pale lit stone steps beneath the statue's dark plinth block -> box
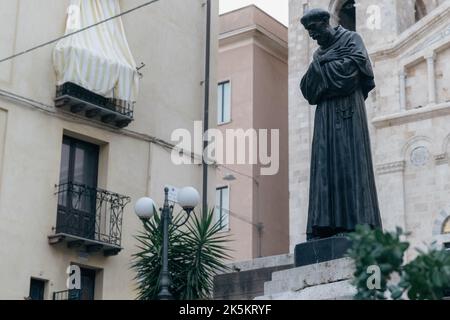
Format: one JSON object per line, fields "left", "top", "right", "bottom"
{"left": 255, "top": 258, "right": 356, "bottom": 300}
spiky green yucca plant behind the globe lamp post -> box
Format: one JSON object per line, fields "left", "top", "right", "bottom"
{"left": 133, "top": 210, "right": 230, "bottom": 300}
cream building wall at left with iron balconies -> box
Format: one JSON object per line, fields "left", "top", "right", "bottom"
{"left": 0, "top": 0, "right": 218, "bottom": 299}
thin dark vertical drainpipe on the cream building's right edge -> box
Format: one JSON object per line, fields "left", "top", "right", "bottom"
{"left": 202, "top": 0, "right": 211, "bottom": 216}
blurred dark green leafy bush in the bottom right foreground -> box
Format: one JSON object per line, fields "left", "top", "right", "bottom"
{"left": 349, "top": 226, "right": 450, "bottom": 300}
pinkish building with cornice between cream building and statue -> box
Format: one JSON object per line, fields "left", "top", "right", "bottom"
{"left": 216, "top": 5, "right": 289, "bottom": 261}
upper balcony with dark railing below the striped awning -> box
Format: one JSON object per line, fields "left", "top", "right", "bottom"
{"left": 55, "top": 82, "right": 134, "bottom": 128}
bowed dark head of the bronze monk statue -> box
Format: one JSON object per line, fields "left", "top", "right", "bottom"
{"left": 300, "top": 9, "right": 333, "bottom": 46}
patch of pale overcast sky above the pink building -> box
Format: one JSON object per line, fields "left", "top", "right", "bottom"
{"left": 219, "top": 0, "right": 289, "bottom": 26}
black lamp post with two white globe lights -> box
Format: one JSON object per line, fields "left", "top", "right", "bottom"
{"left": 134, "top": 187, "right": 200, "bottom": 300}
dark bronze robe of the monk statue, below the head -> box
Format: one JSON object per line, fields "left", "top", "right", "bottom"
{"left": 301, "top": 26, "right": 381, "bottom": 239}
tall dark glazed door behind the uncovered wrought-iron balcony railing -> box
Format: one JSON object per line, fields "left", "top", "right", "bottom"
{"left": 56, "top": 136, "right": 99, "bottom": 239}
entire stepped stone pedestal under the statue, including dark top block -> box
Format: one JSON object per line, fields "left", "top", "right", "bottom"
{"left": 214, "top": 237, "right": 356, "bottom": 300}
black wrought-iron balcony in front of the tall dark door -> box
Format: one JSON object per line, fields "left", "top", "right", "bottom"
{"left": 48, "top": 183, "right": 131, "bottom": 256}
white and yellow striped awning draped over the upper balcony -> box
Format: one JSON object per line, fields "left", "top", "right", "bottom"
{"left": 53, "top": 0, "right": 139, "bottom": 102}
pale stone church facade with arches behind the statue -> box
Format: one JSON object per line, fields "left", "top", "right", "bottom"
{"left": 289, "top": 0, "right": 450, "bottom": 258}
